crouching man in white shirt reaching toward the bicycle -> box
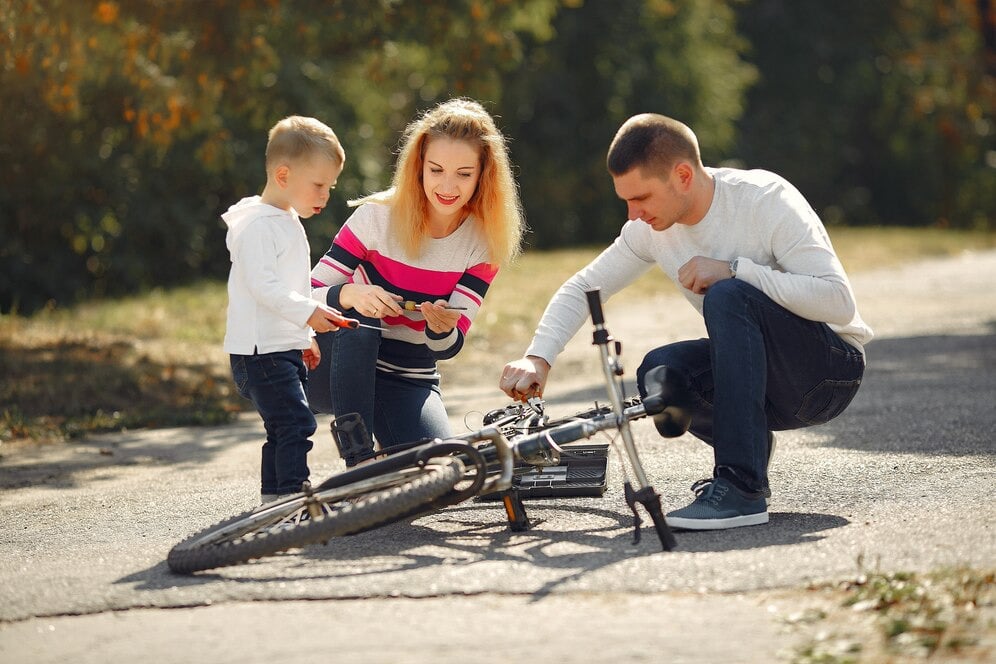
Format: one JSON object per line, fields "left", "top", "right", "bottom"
{"left": 499, "top": 113, "right": 872, "bottom": 530}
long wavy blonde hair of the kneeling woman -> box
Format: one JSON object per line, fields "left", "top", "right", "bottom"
{"left": 349, "top": 99, "right": 524, "bottom": 265}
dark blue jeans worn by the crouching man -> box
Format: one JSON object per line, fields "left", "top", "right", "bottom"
{"left": 637, "top": 279, "right": 865, "bottom": 493}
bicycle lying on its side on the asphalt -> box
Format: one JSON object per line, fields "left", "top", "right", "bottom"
{"left": 167, "top": 289, "right": 690, "bottom": 574}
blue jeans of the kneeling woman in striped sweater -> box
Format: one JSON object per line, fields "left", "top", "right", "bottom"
{"left": 308, "top": 311, "right": 452, "bottom": 448}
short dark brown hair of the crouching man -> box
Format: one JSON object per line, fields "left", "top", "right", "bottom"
{"left": 605, "top": 113, "right": 702, "bottom": 176}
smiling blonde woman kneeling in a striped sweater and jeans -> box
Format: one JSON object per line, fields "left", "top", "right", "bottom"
{"left": 308, "top": 99, "right": 523, "bottom": 467}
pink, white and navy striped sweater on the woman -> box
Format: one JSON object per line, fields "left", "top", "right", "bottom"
{"left": 311, "top": 203, "right": 497, "bottom": 382}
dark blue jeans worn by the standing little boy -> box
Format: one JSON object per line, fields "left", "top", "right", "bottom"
{"left": 230, "top": 350, "right": 317, "bottom": 494}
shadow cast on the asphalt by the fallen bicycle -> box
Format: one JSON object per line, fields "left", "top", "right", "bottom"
{"left": 117, "top": 501, "right": 850, "bottom": 600}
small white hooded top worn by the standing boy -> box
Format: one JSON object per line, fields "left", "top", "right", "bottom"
{"left": 221, "top": 196, "right": 319, "bottom": 355}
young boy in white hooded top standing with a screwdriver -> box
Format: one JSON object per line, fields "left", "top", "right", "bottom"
{"left": 222, "top": 116, "right": 346, "bottom": 503}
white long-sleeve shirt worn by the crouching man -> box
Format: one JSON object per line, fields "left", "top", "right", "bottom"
{"left": 526, "top": 168, "right": 873, "bottom": 365}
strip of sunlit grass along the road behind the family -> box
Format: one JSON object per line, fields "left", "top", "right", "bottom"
{"left": 0, "top": 228, "right": 996, "bottom": 442}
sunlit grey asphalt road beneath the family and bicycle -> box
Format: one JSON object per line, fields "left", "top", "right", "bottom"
{"left": 0, "top": 252, "right": 996, "bottom": 664}
